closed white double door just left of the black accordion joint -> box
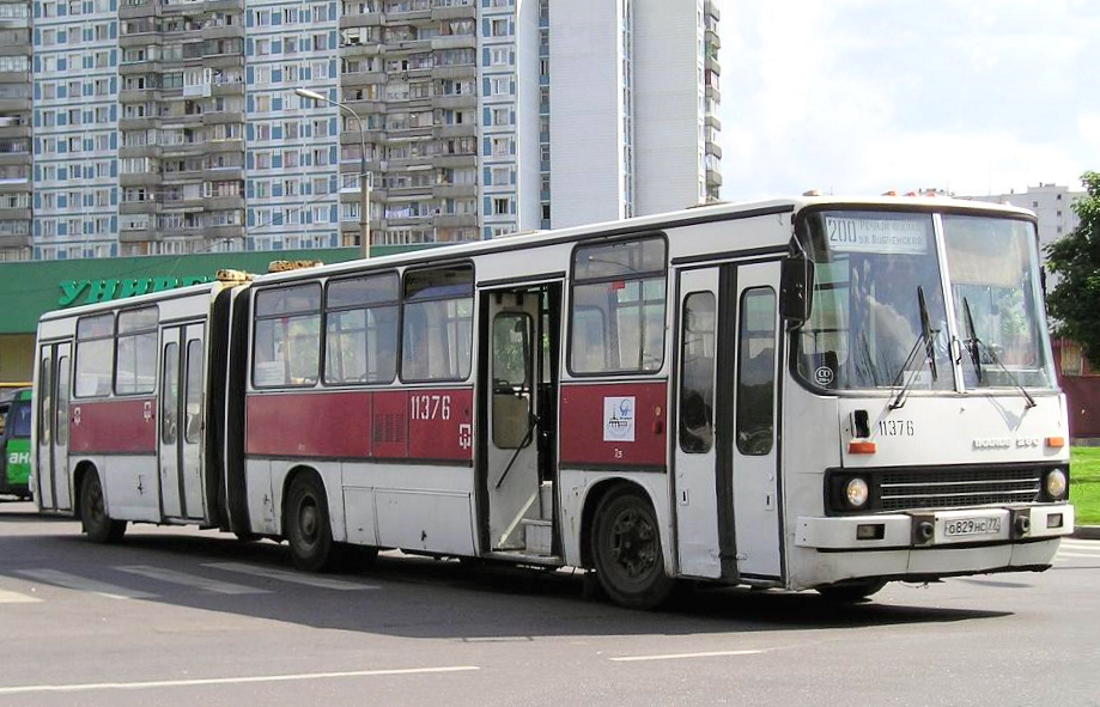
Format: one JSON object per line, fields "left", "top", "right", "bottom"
{"left": 158, "top": 324, "right": 206, "bottom": 520}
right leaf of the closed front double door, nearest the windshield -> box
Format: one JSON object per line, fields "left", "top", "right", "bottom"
{"left": 724, "top": 262, "right": 782, "bottom": 579}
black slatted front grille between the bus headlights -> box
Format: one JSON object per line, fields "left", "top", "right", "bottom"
{"left": 879, "top": 468, "right": 1042, "bottom": 511}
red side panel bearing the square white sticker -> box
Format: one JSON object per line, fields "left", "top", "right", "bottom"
{"left": 561, "top": 382, "right": 669, "bottom": 466}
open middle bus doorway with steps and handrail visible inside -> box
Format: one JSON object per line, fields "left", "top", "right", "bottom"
{"left": 477, "top": 283, "right": 561, "bottom": 555}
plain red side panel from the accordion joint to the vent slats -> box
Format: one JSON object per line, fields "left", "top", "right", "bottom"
{"left": 245, "top": 393, "right": 371, "bottom": 457}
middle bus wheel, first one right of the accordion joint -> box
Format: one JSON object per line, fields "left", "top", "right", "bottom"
{"left": 286, "top": 473, "right": 339, "bottom": 572}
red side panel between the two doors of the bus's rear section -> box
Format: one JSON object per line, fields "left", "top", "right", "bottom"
{"left": 69, "top": 398, "right": 156, "bottom": 454}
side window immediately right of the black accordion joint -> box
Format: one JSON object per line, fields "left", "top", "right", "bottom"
{"left": 252, "top": 283, "right": 321, "bottom": 388}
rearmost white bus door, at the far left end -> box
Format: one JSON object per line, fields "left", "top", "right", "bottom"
{"left": 34, "top": 342, "right": 73, "bottom": 510}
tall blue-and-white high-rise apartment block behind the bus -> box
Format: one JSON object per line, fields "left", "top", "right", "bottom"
{"left": 12, "top": 0, "right": 721, "bottom": 259}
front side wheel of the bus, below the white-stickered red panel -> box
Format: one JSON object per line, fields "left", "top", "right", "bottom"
{"left": 592, "top": 488, "right": 673, "bottom": 609}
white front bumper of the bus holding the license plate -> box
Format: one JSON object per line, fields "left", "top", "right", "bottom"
{"left": 794, "top": 504, "right": 1074, "bottom": 551}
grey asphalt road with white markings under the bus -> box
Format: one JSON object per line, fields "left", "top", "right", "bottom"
{"left": 0, "top": 502, "right": 1100, "bottom": 707}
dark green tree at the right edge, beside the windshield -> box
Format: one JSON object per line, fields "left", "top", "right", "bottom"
{"left": 1046, "top": 172, "right": 1100, "bottom": 368}
